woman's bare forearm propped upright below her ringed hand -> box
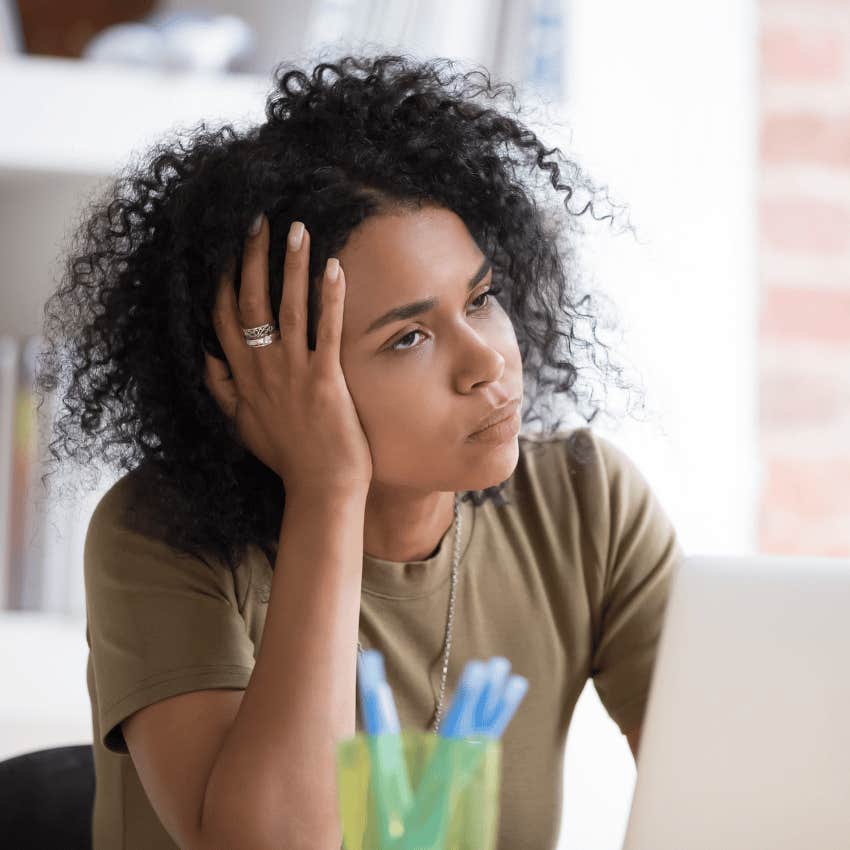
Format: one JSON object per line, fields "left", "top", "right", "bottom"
{"left": 201, "top": 489, "right": 366, "bottom": 850}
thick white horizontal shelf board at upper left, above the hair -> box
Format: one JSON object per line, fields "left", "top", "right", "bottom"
{"left": 0, "top": 55, "right": 274, "bottom": 182}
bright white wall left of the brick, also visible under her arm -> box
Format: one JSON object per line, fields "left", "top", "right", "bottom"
{"left": 558, "top": 0, "right": 760, "bottom": 850}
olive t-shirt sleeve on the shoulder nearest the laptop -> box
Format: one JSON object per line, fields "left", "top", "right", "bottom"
{"left": 591, "top": 435, "right": 684, "bottom": 734}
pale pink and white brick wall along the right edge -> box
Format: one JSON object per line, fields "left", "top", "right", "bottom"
{"left": 759, "top": 0, "right": 850, "bottom": 557}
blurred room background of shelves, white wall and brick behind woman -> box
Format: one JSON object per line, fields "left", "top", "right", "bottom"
{"left": 0, "top": 0, "right": 850, "bottom": 850}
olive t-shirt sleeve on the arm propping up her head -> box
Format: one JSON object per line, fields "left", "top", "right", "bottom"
{"left": 84, "top": 480, "right": 254, "bottom": 753}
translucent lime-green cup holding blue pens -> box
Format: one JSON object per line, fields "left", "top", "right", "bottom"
{"left": 336, "top": 729, "right": 502, "bottom": 850}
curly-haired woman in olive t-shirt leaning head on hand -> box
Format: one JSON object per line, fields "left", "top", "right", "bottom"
{"left": 39, "top": 49, "right": 681, "bottom": 850}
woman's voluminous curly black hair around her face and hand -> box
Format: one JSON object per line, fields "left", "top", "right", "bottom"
{"left": 35, "top": 53, "right": 644, "bottom": 569}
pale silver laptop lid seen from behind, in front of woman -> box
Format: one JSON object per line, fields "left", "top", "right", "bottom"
{"left": 623, "top": 555, "right": 850, "bottom": 850}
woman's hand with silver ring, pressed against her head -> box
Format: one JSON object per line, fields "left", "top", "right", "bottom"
{"left": 204, "top": 215, "right": 372, "bottom": 490}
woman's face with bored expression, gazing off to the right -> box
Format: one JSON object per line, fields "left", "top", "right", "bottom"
{"left": 338, "top": 207, "right": 522, "bottom": 492}
